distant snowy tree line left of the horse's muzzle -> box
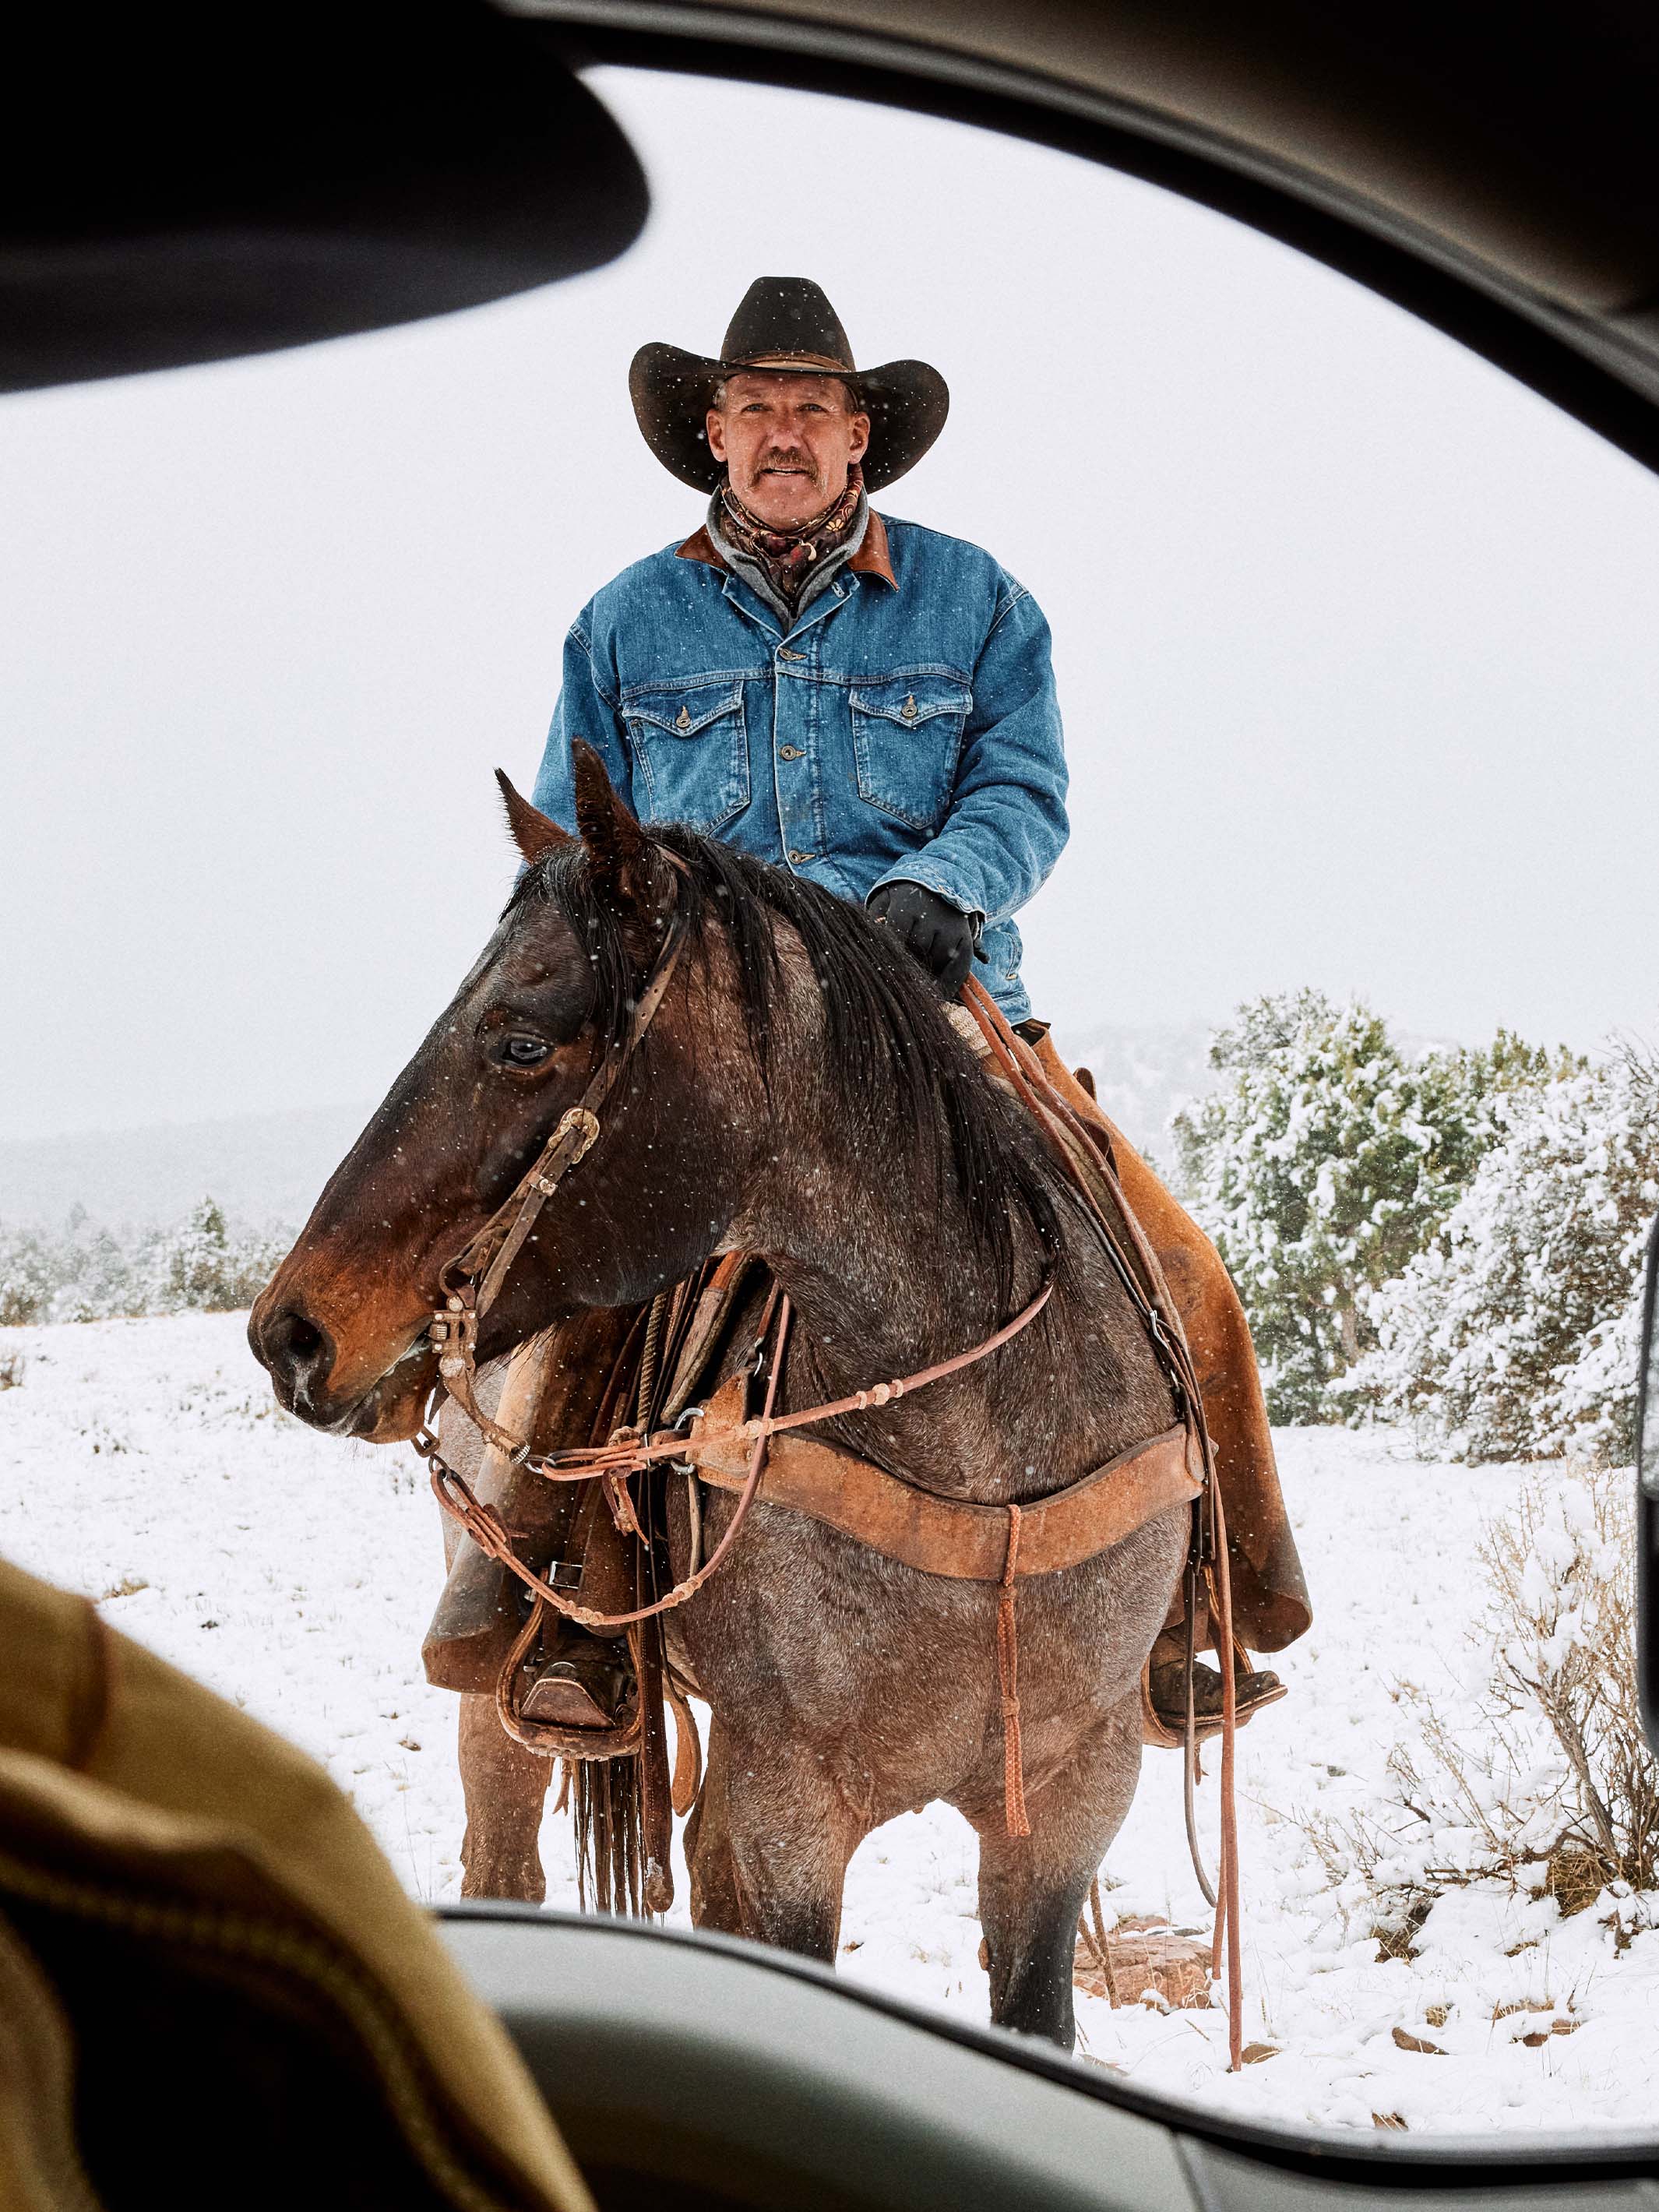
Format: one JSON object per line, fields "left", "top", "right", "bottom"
{"left": 0, "top": 1199, "right": 292, "bottom": 1327}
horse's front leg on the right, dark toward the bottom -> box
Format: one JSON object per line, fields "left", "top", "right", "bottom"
{"left": 971, "top": 1685, "right": 1141, "bottom": 2051}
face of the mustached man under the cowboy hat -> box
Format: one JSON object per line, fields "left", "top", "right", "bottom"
{"left": 708, "top": 369, "right": 869, "bottom": 531}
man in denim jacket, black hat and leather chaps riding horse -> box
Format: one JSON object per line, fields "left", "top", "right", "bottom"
{"left": 424, "top": 276, "right": 1312, "bottom": 1743}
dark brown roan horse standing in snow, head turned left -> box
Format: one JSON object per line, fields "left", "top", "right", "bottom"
{"left": 250, "top": 745, "right": 1190, "bottom": 2046}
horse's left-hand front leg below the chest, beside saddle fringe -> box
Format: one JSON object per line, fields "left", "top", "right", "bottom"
{"left": 692, "top": 1725, "right": 858, "bottom": 1967}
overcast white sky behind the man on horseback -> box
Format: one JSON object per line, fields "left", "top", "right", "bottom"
{"left": 0, "top": 71, "right": 1659, "bottom": 1137}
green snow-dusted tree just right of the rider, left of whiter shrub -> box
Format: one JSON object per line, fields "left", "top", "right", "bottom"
{"left": 1172, "top": 991, "right": 1551, "bottom": 1420}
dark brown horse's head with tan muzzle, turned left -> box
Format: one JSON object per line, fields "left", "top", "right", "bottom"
{"left": 248, "top": 745, "right": 766, "bottom": 1442}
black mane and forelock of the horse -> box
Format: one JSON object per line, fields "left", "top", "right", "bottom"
{"left": 506, "top": 822, "right": 1071, "bottom": 1309}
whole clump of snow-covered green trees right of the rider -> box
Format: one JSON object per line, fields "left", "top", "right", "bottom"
{"left": 1172, "top": 991, "right": 1659, "bottom": 1462}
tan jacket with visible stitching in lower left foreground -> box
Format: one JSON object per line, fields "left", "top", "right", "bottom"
{"left": 0, "top": 1562, "right": 590, "bottom": 2212}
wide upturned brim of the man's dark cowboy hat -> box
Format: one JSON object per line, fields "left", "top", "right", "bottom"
{"left": 629, "top": 345, "right": 951, "bottom": 491}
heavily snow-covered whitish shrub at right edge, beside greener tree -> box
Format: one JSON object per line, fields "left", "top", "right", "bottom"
{"left": 1349, "top": 1053, "right": 1659, "bottom": 1460}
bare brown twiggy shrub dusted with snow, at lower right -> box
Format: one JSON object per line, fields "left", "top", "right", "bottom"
{"left": 1303, "top": 1469, "right": 1659, "bottom": 1951}
